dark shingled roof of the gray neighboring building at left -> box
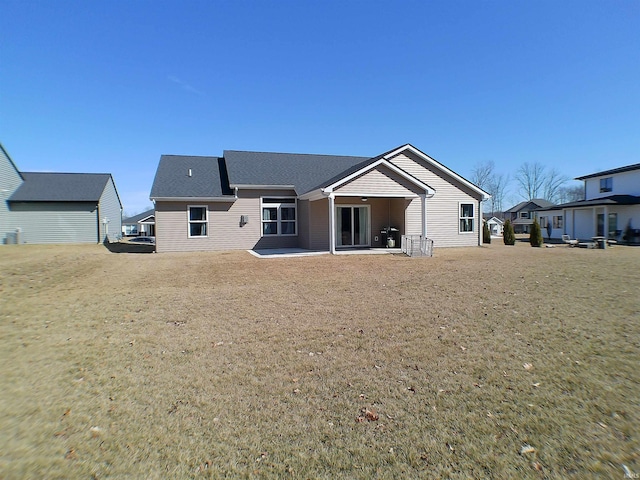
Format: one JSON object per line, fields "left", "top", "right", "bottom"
{"left": 9, "top": 172, "right": 111, "bottom": 202}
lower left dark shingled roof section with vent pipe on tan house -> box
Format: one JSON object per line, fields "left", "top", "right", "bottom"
{"left": 150, "top": 155, "right": 233, "bottom": 198}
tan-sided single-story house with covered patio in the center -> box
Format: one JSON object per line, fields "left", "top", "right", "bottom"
{"left": 150, "top": 144, "right": 488, "bottom": 253}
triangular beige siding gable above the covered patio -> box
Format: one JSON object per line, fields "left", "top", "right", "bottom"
{"left": 335, "top": 166, "right": 424, "bottom": 197}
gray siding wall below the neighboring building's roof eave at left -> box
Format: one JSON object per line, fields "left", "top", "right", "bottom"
{"left": 11, "top": 202, "right": 98, "bottom": 243}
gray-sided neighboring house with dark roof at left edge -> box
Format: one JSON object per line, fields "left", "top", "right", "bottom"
{"left": 0, "top": 145, "right": 122, "bottom": 244}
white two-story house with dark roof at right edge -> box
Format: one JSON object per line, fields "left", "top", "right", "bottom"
{"left": 536, "top": 163, "right": 640, "bottom": 242}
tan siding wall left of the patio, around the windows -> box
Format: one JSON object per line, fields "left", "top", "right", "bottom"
{"left": 155, "top": 190, "right": 300, "bottom": 252}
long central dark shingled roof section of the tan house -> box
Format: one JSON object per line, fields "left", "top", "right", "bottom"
{"left": 224, "top": 150, "right": 371, "bottom": 195}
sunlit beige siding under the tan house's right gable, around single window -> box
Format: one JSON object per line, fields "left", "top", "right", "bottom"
{"left": 390, "top": 154, "right": 482, "bottom": 247}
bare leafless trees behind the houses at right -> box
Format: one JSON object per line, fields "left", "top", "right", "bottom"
{"left": 471, "top": 160, "right": 584, "bottom": 213}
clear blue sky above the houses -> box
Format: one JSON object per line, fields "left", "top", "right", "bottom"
{"left": 0, "top": 0, "right": 640, "bottom": 214}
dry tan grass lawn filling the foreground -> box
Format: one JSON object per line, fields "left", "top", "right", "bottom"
{"left": 0, "top": 244, "right": 640, "bottom": 479}
